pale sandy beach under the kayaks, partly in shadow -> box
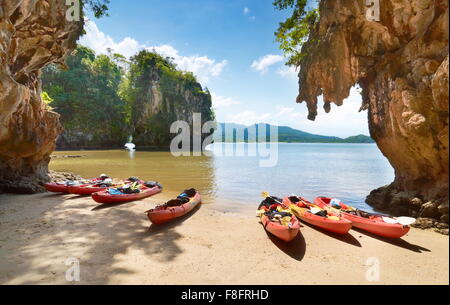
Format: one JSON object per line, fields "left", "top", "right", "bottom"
{"left": 0, "top": 193, "right": 449, "bottom": 284}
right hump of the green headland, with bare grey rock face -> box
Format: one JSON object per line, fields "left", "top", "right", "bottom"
{"left": 130, "top": 51, "right": 214, "bottom": 147}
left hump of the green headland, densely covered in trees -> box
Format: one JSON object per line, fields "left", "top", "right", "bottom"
{"left": 42, "top": 46, "right": 126, "bottom": 146}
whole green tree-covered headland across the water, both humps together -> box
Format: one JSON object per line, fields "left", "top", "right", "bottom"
{"left": 42, "top": 46, "right": 213, "bottom": 148}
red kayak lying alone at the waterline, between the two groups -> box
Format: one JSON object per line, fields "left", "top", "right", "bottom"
{"left": 147, "top": 190, "right": 202, "bottom": 225}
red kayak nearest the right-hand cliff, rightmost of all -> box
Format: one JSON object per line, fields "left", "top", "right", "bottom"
{"left": 314, "top": 197, "right": 410, "bottom": 238}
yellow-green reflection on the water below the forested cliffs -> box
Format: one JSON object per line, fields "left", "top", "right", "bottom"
{"left": 50, "top": 150, "right": 215, "bottom": 199}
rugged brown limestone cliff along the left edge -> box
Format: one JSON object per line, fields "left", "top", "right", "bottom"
{"left": 0, "top": 0, "right": 82, "bottom": 192}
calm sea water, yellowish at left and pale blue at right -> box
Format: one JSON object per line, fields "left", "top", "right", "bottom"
{"left": 50, "top": 144, "right": 394, "bottom": 211}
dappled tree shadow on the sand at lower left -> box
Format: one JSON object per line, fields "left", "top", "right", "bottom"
{"left": 0, "top": 194, "right": 188, "bottom": 284}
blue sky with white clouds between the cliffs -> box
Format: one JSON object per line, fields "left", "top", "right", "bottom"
{"left": 81, "top": 0, "right": 368, "bottom": 137}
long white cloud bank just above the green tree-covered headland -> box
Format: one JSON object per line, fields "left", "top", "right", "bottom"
{"left": 80, "top": 20, "right": 228, "bottom": 83}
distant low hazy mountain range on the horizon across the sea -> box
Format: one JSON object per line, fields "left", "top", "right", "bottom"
{"left": 214, "top": 123, "right": 375, "bottom": 143}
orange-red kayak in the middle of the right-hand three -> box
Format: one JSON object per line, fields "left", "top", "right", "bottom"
{"left": 283, "top": 197, "right": 352, "bottom": 235}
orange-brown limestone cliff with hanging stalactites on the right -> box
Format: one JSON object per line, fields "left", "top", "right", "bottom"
{"left": 297, "top": 0, "right": 449, "bottom": 228}
